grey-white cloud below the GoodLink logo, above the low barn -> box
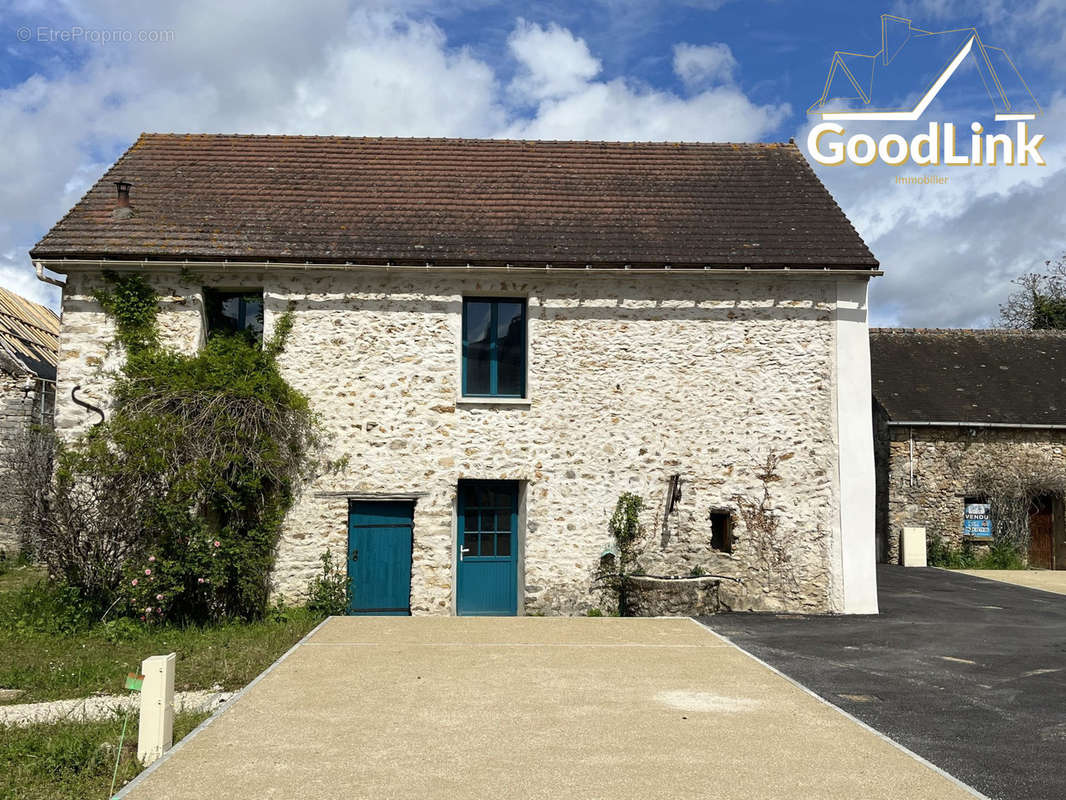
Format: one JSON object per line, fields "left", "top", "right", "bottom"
{"left": 796, "top": 95, "right": 1066, "bottom": 327}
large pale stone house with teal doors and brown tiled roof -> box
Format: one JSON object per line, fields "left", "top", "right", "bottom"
{"left": 31, "top": 134, "right": 879, "bottom": 614}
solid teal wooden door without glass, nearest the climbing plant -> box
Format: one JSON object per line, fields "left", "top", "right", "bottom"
{"left": 348, "top": 500, "right": 415, "bottom": 615}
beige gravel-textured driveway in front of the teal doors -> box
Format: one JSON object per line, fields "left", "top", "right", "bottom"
{"left": 120, "top": 618, "right": 973, "bottom": 800}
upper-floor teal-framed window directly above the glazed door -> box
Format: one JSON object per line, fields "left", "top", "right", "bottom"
{"left": 463, "top": 298, "right": 526, "bottom": 398}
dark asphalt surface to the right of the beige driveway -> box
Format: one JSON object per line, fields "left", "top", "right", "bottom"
{"left": 706, "top": 565, "right": 1066, "bottom": 800}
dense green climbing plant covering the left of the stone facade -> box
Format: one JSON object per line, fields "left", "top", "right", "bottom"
{"left": 56, "top": 273, "right": 319, "bottom": 622}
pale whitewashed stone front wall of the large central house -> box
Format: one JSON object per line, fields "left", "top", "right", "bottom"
{"left": 58, "top": 270, "right": 840, "bottom": 614}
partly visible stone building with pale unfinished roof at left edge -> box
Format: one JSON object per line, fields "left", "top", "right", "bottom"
{"left": 0, "top": 288, "right": 60, "bottom": 555}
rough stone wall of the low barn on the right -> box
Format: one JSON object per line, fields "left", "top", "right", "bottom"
{"left": 877, "top": 425, "right": 1066, "bottom": 564}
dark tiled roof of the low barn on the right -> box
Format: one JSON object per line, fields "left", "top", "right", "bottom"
{"left": 870, "top": 327, "right": 1066, "bottom": 425}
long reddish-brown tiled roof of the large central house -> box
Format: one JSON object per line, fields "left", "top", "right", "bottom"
{"left": 31, "top": 133, "right": 877, "bottom": 269}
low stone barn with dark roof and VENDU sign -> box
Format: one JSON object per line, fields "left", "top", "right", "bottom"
{"left": 870, "top": 329, "right": 1066, "bottom": 569}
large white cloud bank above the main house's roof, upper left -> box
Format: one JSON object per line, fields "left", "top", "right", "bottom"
{"left": 0, "top": 0, "right": 788, "bottom": 304}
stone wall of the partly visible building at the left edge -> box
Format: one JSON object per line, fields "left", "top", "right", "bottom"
{"left": 0, "top": 352, "right": 51, "bottom": 556}
